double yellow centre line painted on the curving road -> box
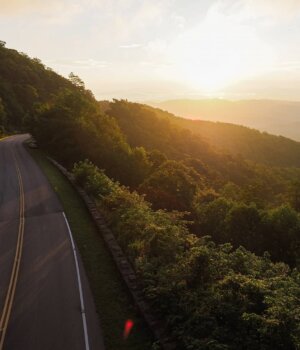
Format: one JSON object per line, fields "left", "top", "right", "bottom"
{"left": 0, "top": 146, "right": 25, "bottom": 350}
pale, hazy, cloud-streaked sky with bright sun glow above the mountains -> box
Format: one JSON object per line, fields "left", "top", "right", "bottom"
{"left": 0, "top": 0, "right": 300, "bottom": 101}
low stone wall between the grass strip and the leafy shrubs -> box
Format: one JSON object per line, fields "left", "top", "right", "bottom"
{"left": 48, "top": 157, "right": 177, "bottom": 350}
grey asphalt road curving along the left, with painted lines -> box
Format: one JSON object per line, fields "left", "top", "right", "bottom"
{"left": 0, "top": 135, "right": 104, "bottom": 350}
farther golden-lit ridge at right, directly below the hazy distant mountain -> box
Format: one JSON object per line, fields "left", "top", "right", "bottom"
{"left": 148, "top": 105, "right": 300, "bottom": 167}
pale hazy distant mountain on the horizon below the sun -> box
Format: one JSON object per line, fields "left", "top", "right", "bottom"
{"left": 148, "top": 99, "right": 300, "bottom": 141}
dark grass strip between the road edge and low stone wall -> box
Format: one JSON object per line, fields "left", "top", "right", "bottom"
{"left": 28, "top": 149, "right": 152, "bottom": 350}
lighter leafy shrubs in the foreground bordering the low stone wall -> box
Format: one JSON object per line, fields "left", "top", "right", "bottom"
{"left": 73, "top": 161, "right": 300, "bottom": 350}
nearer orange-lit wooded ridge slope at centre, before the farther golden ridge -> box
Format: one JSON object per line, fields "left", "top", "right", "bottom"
{"left": 105, "top": 100, "right": 268, "bottom": 185}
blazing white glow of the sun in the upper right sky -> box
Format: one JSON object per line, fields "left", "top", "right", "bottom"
{"left": 170, "top": 4, "right": 271, "bottom": 93}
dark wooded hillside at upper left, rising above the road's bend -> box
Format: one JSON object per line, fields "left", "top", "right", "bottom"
{"left": 0, "top": 42, "right": 72, "bottom": 129}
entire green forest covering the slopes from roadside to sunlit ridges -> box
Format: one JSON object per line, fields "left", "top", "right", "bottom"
{"left": 0, "top": 42, "right": 300, "bottom": 350}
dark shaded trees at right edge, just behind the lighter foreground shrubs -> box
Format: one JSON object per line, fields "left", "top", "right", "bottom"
{"left": 194, "top": 197, "right": 300, "bottom": 266}
